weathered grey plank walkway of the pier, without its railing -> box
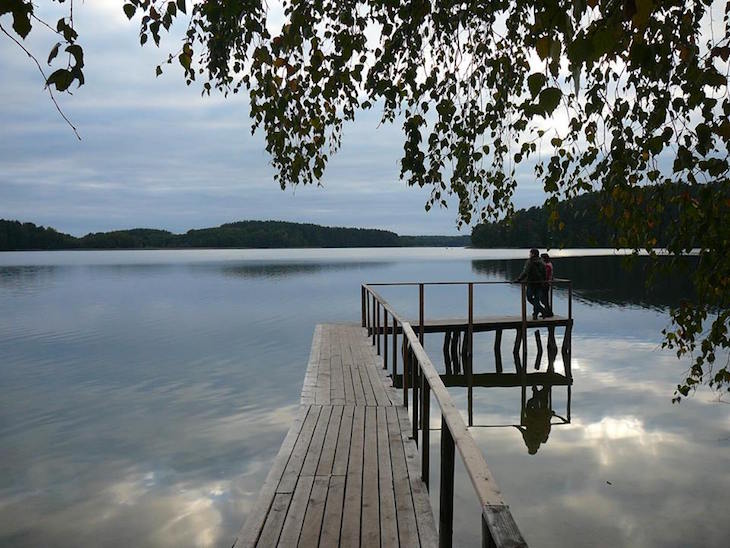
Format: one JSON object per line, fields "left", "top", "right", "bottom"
{"left": 234, "top": 324, "right": 438, "bottom": 548}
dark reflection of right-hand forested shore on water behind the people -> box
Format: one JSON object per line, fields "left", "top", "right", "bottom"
{"left": 472, "top": 256, "right": 696, "bottom": 310}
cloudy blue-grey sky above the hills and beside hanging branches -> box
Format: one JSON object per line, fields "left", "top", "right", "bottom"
{"left": 0, "top": 0, "right": 544, "bottom": 236}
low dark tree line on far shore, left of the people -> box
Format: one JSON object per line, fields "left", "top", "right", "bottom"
{"left": 0, "top": 219, "right": 469, "bottom": 251}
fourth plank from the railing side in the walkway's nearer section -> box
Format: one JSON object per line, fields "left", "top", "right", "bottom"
{"left": 361, "top": 407, "right": 380, "bottom": 546}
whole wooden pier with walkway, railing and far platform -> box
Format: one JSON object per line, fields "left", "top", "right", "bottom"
{"left": 234, "top": 280, "right": 573, "bottom": 548}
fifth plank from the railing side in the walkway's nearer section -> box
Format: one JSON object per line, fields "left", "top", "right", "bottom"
{"left": 341, "top": 406, "right": 366, "bottom": 546}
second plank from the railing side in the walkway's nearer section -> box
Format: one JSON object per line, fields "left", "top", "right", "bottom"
{"left": 385, "top": 407, "right": 418, "bottom": 547}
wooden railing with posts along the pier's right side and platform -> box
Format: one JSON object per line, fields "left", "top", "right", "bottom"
{"left": 361, "top": 280, "right": 572, "bottom": 548}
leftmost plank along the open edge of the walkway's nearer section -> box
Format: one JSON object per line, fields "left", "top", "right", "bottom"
{"left": 235, "top": 406, "right": 310, "bottom": 548}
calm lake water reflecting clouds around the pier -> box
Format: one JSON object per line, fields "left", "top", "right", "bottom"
{"left": 0, "top": 249, "right": 730, "bottom": 547}
